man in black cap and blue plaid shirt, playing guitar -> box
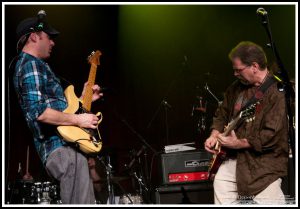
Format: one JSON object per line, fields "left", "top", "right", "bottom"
{"left": 13, "top": 10, "right": 103, "bottom": 204}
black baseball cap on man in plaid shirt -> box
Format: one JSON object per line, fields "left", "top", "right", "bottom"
{"left": 16, "top": 17, "right": 59, "bottom": 40}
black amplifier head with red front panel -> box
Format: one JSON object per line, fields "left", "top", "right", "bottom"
{"left": 160, "top": 150, "right": 212, "bottom": 184}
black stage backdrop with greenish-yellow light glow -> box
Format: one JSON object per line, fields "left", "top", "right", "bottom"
{"left": 2, "top": 4, "right": 296, "bottom": 196}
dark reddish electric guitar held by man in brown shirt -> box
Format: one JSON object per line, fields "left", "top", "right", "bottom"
{"left": 208, "top": 102, "right": 259, "bottom": 180}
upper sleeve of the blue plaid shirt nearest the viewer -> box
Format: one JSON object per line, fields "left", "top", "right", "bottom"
{"left": 19, "top": 61, "right": 66, "bottom": 121}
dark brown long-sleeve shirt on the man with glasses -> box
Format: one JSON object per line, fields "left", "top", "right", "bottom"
{"left": 211, "top": 75, "right": 288, "bottom": 196}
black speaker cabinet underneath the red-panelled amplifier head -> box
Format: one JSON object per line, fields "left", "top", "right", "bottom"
{"left": 155, "top": 181, "right": 214, "bottom": 204}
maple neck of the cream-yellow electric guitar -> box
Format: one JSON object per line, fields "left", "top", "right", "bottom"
{"left": 82, "top": 63, "right": 97, "bottom": 111}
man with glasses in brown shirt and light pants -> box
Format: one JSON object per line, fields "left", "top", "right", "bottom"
{"left": 205, "top": 42, "right": 288, "bottom": 204}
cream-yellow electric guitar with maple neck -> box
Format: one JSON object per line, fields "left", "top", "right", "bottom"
{"left": 57, "top": 50, "right": 102, "bottom": 154}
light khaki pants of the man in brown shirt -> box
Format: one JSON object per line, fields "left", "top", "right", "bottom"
{"left": 214, "top": 159, "right": 285, "bottom": 205}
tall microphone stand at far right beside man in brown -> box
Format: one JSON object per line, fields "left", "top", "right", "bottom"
{"left": 255, "top": 7, "right": 295, "bottom": 197}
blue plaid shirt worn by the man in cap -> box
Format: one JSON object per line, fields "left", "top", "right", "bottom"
{"left": 14, "top": 52, "right": 67, "bottom": 163}
